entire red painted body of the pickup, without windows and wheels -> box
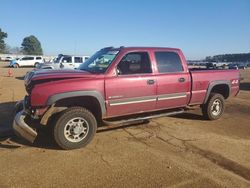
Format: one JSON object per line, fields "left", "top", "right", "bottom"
{"left": 25, "top": 47, "right": 239, "bottom": 117}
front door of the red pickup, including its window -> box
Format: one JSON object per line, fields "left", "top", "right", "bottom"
{"left": 105, "top": 52, "right": 156, "bottom": 117}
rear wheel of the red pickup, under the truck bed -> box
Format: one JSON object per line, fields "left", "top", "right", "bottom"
{"left": 201, "top": 93, "right": 225, "bottom": 120}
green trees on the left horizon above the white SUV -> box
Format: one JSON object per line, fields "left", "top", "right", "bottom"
{"left": 0, "top": 28, "right": 43, "bottom": 55}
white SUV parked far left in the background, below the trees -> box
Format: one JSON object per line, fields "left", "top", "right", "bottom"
{"left": 9, "top": 56, "right": 44, "bottom": 68}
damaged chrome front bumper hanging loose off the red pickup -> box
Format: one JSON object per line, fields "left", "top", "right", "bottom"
{"left": 12, "top": 101, "right": 37, "bottom": 143}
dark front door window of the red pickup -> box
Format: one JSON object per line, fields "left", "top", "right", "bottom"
{"left": 117, "top": 52, "right": 152, "bottom": 75}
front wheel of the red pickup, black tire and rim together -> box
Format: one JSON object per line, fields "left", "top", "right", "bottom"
{"left": 54, "top": 107, "right": 97, "bottom": 150}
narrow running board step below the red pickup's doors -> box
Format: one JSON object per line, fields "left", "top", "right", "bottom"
{"left": 98, "top": 109, "right": 185, "bottom": 130}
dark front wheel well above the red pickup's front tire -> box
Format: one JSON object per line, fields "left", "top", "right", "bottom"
{"left": 55, "top": 96, "right": 102, "bottom": 122}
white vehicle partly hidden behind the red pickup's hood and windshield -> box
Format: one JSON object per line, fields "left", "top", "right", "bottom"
{"left": 39, "top": 54, "right": 89, "bottom": 69}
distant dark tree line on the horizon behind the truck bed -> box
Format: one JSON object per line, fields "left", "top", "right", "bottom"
{"left": 205, "top": 53, "right": 250, "bottom": 62}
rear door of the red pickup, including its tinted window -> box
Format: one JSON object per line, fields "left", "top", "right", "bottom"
{"left": 154, "top": 51, "right": 191, "bottom": 109}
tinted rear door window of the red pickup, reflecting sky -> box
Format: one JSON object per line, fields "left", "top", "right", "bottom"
{"left": 155, "top": 52, "right": 183, "bottom": 73}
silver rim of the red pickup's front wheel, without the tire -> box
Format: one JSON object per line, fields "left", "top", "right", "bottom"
{"left": 64, "top": 117, "right": 89, "bottom": 142}
